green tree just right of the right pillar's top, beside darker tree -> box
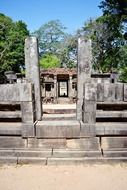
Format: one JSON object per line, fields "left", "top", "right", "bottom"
{"left": 84, "top": 15, "right": 123, "bottom": 72}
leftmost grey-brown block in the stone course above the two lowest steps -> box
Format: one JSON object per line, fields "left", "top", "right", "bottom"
{"left": 0, "top": 136, "right": 27, "bottom": 148}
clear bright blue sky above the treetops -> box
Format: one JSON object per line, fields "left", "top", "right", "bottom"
{"left": 0, "top": 0, "right": 102, "bottom": 33}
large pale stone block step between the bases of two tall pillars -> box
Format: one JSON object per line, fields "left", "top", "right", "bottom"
{"left": 36, "top": 120, "right": 80, "bottom": 138}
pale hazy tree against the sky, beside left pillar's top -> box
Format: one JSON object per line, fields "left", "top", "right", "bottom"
{"left": 32, "top": 20, "right": 66, "bottom": 55}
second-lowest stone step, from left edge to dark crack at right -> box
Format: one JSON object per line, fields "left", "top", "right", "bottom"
{"left": 0, "top": 149, "right": 102, "bottom": 158}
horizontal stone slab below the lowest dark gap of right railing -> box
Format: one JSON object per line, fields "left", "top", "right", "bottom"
{"left": 96, "top": 122, "right": 127, "bottom": 136}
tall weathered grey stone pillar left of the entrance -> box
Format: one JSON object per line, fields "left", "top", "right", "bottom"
{"left": 25, "top": 37, "right": 42, "bottom": 120}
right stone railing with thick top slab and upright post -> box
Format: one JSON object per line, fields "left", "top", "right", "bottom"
{"left": 82, "top": 82, "right": 127, "bottom": 127}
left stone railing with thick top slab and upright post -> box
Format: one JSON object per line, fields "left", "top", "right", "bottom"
{"left": 0, "top": 83, "right": 36, "bottom": 137}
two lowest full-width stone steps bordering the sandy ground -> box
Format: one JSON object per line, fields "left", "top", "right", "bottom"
{"left": 0, "top": 149, "right": 127, "bottom": 165}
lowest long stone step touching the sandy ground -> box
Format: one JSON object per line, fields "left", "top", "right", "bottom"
{"left": 0, "top": 157, "right": 127, "bottom": 165}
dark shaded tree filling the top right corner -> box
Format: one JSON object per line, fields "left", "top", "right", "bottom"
{"left": 99, "top": 0, "right": 127, "bottom": 78}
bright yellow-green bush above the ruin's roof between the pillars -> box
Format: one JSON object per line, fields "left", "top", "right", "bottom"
{"left": 40, "top": 54, "right": 60, "bottom": 69}
